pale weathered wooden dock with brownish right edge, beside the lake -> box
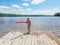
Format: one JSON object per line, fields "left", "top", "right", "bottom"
{"left": 0, "top": 31, "right": 60, "bottom": 45}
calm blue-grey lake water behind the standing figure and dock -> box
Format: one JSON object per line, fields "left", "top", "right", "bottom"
{"left": 0, "top": 17, "right": 60, "bottom": 37}
